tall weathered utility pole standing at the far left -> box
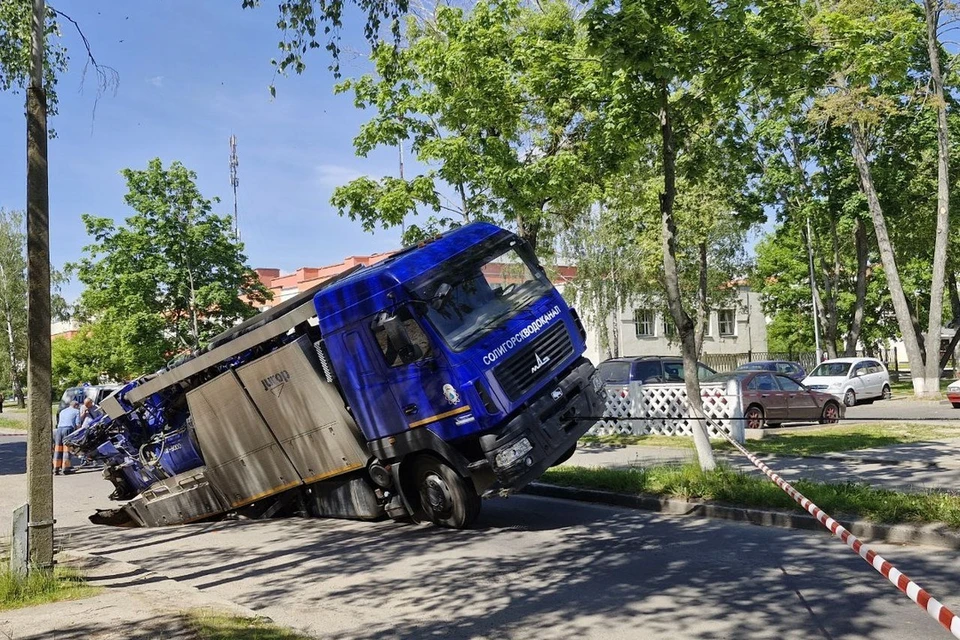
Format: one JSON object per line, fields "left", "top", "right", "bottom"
{"left": 27, "top": 0, "right": 53, "bottom": 569}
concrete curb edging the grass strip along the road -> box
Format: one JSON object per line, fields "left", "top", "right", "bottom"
{"left": 522, "top": 482, "right": 960, "bottom": 549}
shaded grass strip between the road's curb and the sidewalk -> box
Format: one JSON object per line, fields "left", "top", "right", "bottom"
{"left": 543, "top": 464, "right": 960, "bottom": 528}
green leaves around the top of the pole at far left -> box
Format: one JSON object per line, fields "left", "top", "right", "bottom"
{"left": 0, "top": 0, "right": 67, "bottom": 116}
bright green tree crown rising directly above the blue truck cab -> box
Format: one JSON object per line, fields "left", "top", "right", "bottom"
{"left": 332, "top": 0, "right": 602, "bottom": 246}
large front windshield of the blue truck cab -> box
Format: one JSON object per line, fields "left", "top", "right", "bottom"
{"left": 414, "top": 240, "right": 551, "bottom": 350}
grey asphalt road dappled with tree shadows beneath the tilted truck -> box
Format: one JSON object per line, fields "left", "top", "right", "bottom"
{"left": 0, "top": 437, "right": 960, "bottom": 640}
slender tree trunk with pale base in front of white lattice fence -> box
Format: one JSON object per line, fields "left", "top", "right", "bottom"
{"left": 659, "top": 82, "right": 717, "bottom": 471}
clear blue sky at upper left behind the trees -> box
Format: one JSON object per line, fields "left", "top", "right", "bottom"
{"left": 0, "top": 0, "right": 400, "bottom": 297}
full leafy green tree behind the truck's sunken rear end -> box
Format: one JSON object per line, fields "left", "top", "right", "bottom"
{"left": 71, "top": 159, "right": 269, "bottom": 373}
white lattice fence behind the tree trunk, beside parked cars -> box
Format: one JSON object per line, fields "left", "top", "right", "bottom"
{"left": 589, "top": 383, "right": 744, "bottom": 442}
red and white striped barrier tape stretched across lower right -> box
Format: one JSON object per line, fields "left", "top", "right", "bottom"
{"left": 720, "top": 429, "right": 960, "bottom": 638}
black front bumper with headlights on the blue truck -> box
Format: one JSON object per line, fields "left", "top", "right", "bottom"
{"left": 480, "top": 358, "right": 603, "bottom": 496}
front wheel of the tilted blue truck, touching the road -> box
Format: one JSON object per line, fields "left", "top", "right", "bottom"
{"left": 414, "top": 456, "right": 480, "bottom": 529}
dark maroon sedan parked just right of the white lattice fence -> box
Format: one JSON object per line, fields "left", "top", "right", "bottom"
{"left": 702, "top": 371, "right": 844, "bottom": 429}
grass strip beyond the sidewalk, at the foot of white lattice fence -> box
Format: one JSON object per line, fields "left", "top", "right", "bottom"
{"left": 581, "top": 423, "right": 960, "bottom": 456}
